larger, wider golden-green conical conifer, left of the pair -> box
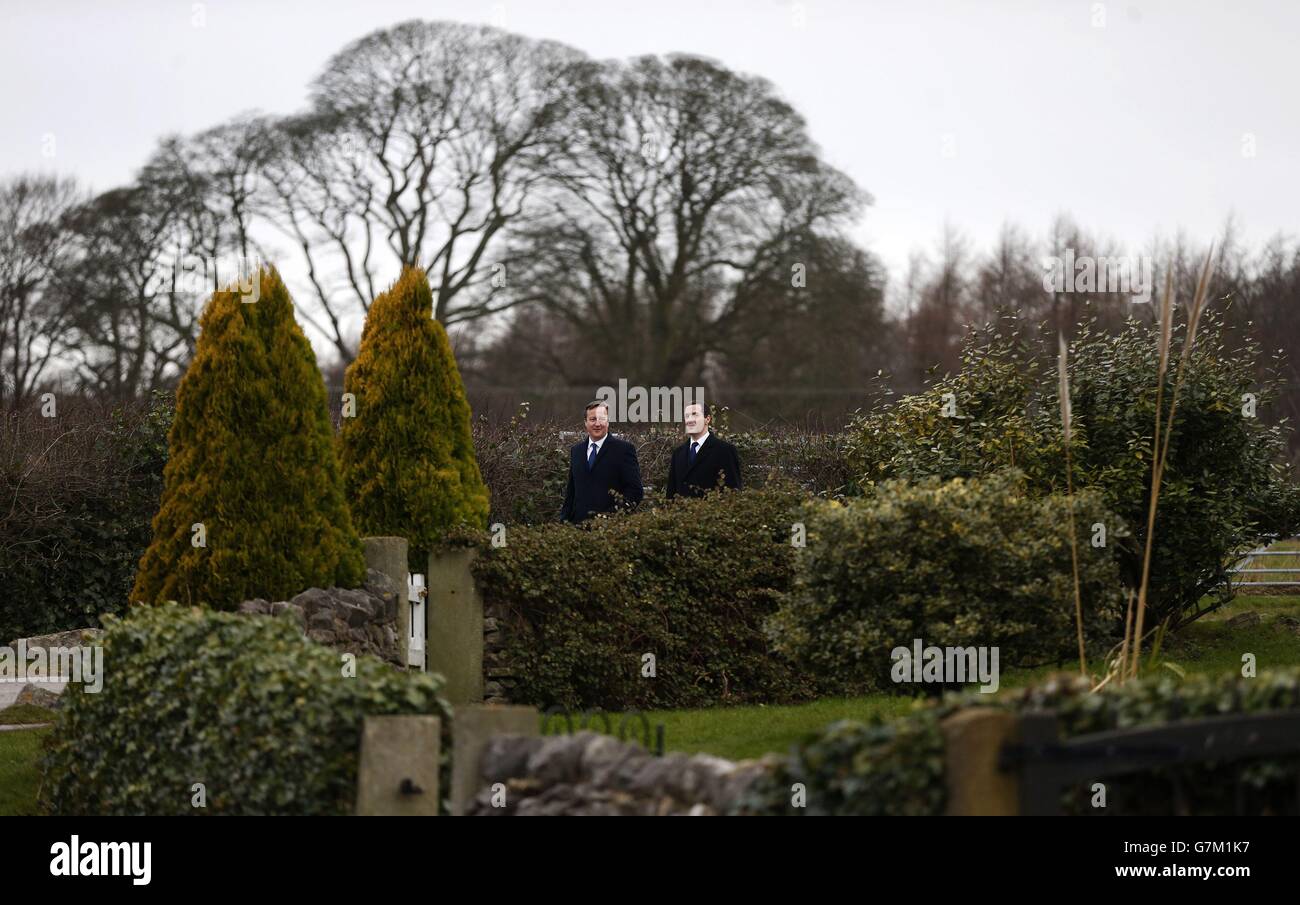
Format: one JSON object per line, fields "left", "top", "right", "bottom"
{"left": 131, "top": 270, "right": 365, "bottom": 609}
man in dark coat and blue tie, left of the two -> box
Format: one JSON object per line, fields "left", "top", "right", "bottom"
{"left": 560, "top": 402, "right": 644, "bottom": 523}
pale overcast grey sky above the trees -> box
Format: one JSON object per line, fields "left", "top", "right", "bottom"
{"left": 0, "top": 0, "right": 1300, "bottom": 276}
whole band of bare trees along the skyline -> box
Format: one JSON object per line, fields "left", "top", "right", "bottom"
{"left": 0, "top": 21, "right": 1300, "bottom": 460}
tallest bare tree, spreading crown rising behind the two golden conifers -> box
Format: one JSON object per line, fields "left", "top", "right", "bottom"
{"left": 257, "top": 21, "right": 580, "bottom": 360}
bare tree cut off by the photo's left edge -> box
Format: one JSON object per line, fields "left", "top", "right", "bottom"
{"left": 0, "top": 176, "right": 81, "bottom": 410}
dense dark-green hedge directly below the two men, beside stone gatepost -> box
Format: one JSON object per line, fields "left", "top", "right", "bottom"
{"left": 475, "top": 488, "right": 857, "bottom": 710}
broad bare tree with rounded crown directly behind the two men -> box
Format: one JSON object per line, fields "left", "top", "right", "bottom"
{"left": 510, "top": 56, "right": 867, "bottom": 385}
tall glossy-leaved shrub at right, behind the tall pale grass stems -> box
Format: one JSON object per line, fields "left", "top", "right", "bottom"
{"left": 848, "top": 313, "right": 1300, "bottom": 627}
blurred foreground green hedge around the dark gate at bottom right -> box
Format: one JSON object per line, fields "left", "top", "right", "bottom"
{"left": 735, "top": 668, "right": 1300, "bottom": 817}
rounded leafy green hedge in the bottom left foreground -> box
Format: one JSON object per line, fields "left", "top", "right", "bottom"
{"left": 42, "top": 606, "right": 450, "bottom": 815}
